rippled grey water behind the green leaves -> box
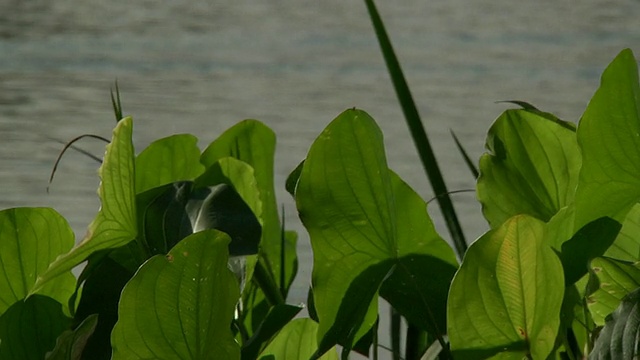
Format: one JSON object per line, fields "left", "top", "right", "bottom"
{"left": 0, "top": 0, "right": 640, "bottom": 338}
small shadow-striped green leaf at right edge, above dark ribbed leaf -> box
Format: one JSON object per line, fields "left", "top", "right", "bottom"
{"left": 587, "top": 257, "right": 640, "bottom": 326}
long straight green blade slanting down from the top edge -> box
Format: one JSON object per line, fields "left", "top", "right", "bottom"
{"left": 365, "top": 0, "right": 467, "bottom": 258}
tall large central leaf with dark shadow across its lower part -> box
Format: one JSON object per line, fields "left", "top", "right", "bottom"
{"left": 296, "top": 109, "right": 456, "bottom": 354}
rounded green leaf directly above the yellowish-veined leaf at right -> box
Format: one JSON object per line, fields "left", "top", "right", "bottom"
{"left": 477, "top": 110, "right": 581, "bottom": 228}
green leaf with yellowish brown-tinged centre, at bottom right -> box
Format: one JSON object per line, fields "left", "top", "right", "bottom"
{"left": 447, "top": 215, "right": 564, "bottom": 359}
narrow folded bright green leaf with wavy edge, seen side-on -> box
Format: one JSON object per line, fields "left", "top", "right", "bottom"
{"left": 30, "top": 117, "right": 138, "bottom": 294}
